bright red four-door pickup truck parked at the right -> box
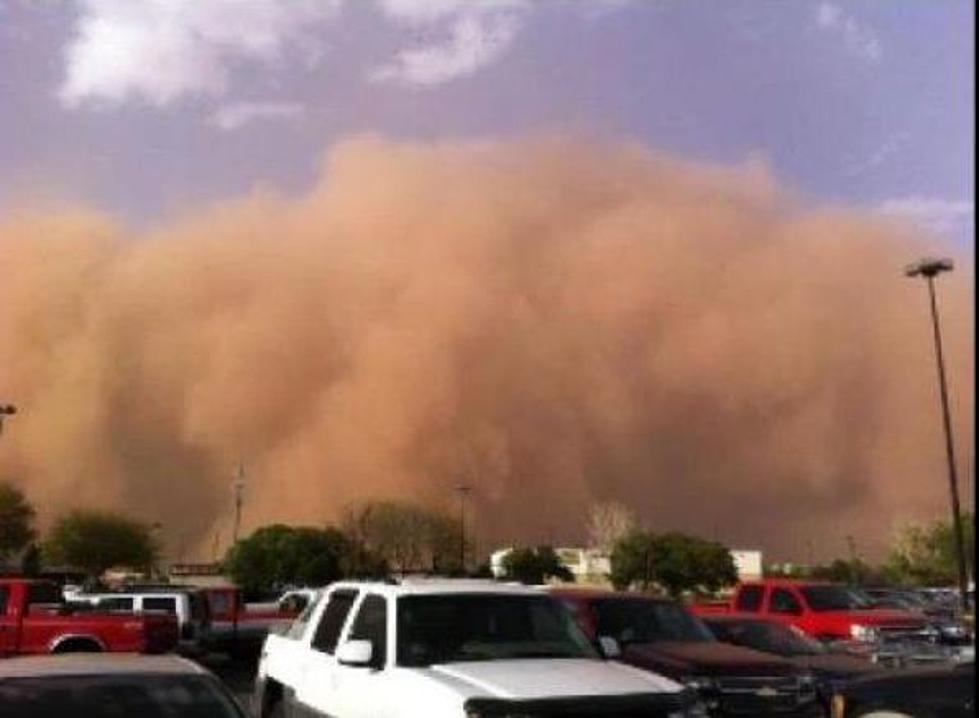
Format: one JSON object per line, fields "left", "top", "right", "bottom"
{"left": 691, "top": 579, "right": 931, "bottom": 643}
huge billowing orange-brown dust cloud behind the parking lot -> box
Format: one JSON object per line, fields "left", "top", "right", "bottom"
{"left": 0, "top": 137, "right": 973, "bottom": 559}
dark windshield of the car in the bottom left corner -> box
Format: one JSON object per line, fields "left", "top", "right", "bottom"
{"left": 0, "top": 675, "right": 243, "bottom": 718}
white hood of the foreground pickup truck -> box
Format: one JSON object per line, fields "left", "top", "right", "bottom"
{"left": 424, "top": 658, "right": 683, "bottom": 700}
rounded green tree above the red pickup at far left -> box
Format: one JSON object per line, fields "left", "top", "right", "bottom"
{"left": 41, "top": 511, "right": 157, "bottom": 578}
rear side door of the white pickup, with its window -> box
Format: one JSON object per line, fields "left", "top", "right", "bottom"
{"left": 293, "top": 588, "right": 359, "bottom": 718}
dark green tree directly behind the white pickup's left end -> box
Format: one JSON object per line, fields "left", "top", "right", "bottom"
{"left": 224, "top": 524, "right": 351, "bottom": 594}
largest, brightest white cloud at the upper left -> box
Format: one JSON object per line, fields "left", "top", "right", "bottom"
{"left": 60, "top": 0, "right": 341, "bottom": 106}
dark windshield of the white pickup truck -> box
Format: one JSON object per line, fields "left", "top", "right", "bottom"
{"left": 397, "top": 594, "right": 599, "bottom": 667}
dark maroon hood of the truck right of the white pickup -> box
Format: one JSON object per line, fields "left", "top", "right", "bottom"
{"left": 622, "top": 641, "right": 799, "bottom": 678}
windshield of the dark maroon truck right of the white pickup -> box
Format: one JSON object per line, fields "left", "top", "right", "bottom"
{"left": 592, "top": 598, "right": 715, "bottom": 645}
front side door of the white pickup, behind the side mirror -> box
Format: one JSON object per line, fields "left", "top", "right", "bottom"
{"left": 333, "top": 593, "right": 388, "bottom": 718}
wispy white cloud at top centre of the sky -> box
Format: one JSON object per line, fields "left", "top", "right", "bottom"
{"left": 370, "top": 0, "right": 532, "bottom": 87}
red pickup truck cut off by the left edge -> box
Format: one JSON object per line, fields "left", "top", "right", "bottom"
{"left": 0, "top": 578, "right": 177, "bottom": 656}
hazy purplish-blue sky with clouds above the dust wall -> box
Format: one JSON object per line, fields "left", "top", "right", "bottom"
{"left": 0, "top": 0, "right": 975, "bottom": 245}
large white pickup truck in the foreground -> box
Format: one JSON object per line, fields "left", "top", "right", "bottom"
{"left": 254, "top": 579, "right": 706, "bottom": 718}
